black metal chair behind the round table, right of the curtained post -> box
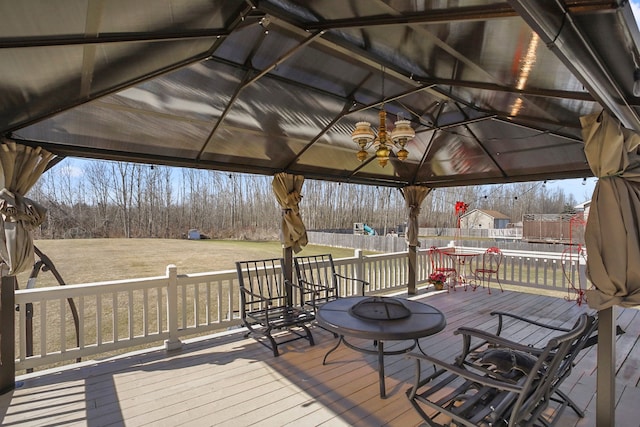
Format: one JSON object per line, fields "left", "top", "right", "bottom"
{"left": 293, "top": 254, "right": 369, "bottom": 313}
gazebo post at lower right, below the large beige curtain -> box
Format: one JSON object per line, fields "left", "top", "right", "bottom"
{"left": 596, "top": 306, "right": 616, "bottom": 427}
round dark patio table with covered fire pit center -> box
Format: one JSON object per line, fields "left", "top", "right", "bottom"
{"left": 316, "top": 297, "right": 447, "bottom": 398}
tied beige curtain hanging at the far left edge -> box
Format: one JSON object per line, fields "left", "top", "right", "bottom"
{"left": 0, "top": 139, "right": 54, "bottom": 275}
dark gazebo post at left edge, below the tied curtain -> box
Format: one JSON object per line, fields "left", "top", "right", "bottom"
{"left": 0, "top": 275, "right": 16, "bottom": 394}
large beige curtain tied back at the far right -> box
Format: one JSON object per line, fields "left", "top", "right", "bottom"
{"left": 580, "top": 112, "right": 640, "bottom": 310}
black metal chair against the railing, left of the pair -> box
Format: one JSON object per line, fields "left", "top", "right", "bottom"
{"left": 236, "top": 258, "right": 315, "bottom": 357}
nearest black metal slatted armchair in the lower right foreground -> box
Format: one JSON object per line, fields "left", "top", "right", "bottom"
{"left": 407, "top": 314, "right": 595, "bottom": 426}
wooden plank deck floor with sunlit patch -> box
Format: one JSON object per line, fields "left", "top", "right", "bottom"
{"left": 0, "top": 289, "right": 640, "bottom": 427}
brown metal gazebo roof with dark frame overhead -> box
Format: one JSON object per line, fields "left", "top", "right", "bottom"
{"left": 0, "top": 0, "right": 640, "bottom": 187}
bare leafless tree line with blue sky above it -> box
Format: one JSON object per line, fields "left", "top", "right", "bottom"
{"left": 27, "top": 159, "right": 576, "bottom": 239}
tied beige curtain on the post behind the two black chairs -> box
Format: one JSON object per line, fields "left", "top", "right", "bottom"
{"left": 272, "top": 172, "right": 308, "bottom": 253}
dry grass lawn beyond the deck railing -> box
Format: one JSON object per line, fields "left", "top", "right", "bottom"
{"left": 18, "top": 239, "right": 362, "bottom": 289}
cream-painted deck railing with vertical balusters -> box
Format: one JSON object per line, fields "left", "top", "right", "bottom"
{"left": 15, "top": 248, "right": 585, "bottom": 371}
